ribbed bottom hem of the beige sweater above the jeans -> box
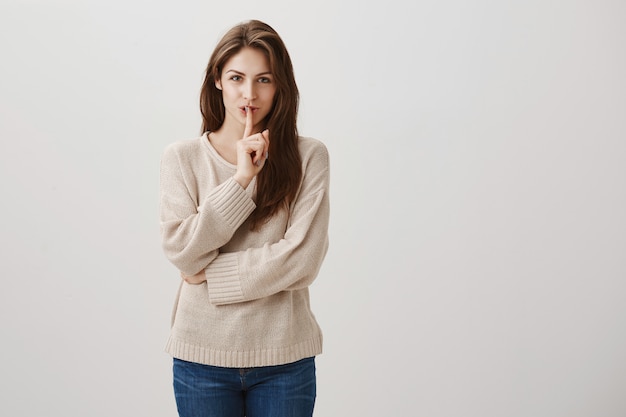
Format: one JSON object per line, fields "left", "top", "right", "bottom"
{"left": 165, "top": 335, "right": 322, "bottom": 368}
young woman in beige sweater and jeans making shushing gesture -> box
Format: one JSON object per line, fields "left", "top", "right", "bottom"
{"left": 160, "top": 21, "right": 329, "bottom": 417}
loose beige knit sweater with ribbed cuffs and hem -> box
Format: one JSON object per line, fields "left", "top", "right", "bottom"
{"left": 160, "top": 134, "right": 329, "bottom": 368}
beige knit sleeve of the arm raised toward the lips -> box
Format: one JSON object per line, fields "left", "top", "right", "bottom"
{"left": 160, "top": 143, "right": 255, "bottom": 275}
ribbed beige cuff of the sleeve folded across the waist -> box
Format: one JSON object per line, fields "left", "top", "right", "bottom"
{"left": 204, "top": 253, "right": 243, "bottom": 304}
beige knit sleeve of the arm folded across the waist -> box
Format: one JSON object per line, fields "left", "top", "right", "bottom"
{"left": 205, "top": 141, "right": 329, "bottom": 305}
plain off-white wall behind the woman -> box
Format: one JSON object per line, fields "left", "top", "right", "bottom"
{"left": 0, "top": 0, "right": 626, "bottom": 417}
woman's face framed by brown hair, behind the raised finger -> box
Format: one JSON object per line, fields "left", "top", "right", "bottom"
{"left": 215, "top": 47, "right": 276, "bottom": 131}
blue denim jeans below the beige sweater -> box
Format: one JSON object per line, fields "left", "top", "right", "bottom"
{"left": 174, "top": 358, "right": 316, "bottom": 417}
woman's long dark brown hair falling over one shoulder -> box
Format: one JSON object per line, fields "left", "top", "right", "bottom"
{"left": 200, "top": 20, "right": 302, "bottom": 229}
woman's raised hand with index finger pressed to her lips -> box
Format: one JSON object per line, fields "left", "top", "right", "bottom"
{"left": 233, "top": 109, "right": 270, "bottom": 188}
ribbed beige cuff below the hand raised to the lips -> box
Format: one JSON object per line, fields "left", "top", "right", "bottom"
{"left": 207, "top": 177, "right": 256, "bottom": 229}
